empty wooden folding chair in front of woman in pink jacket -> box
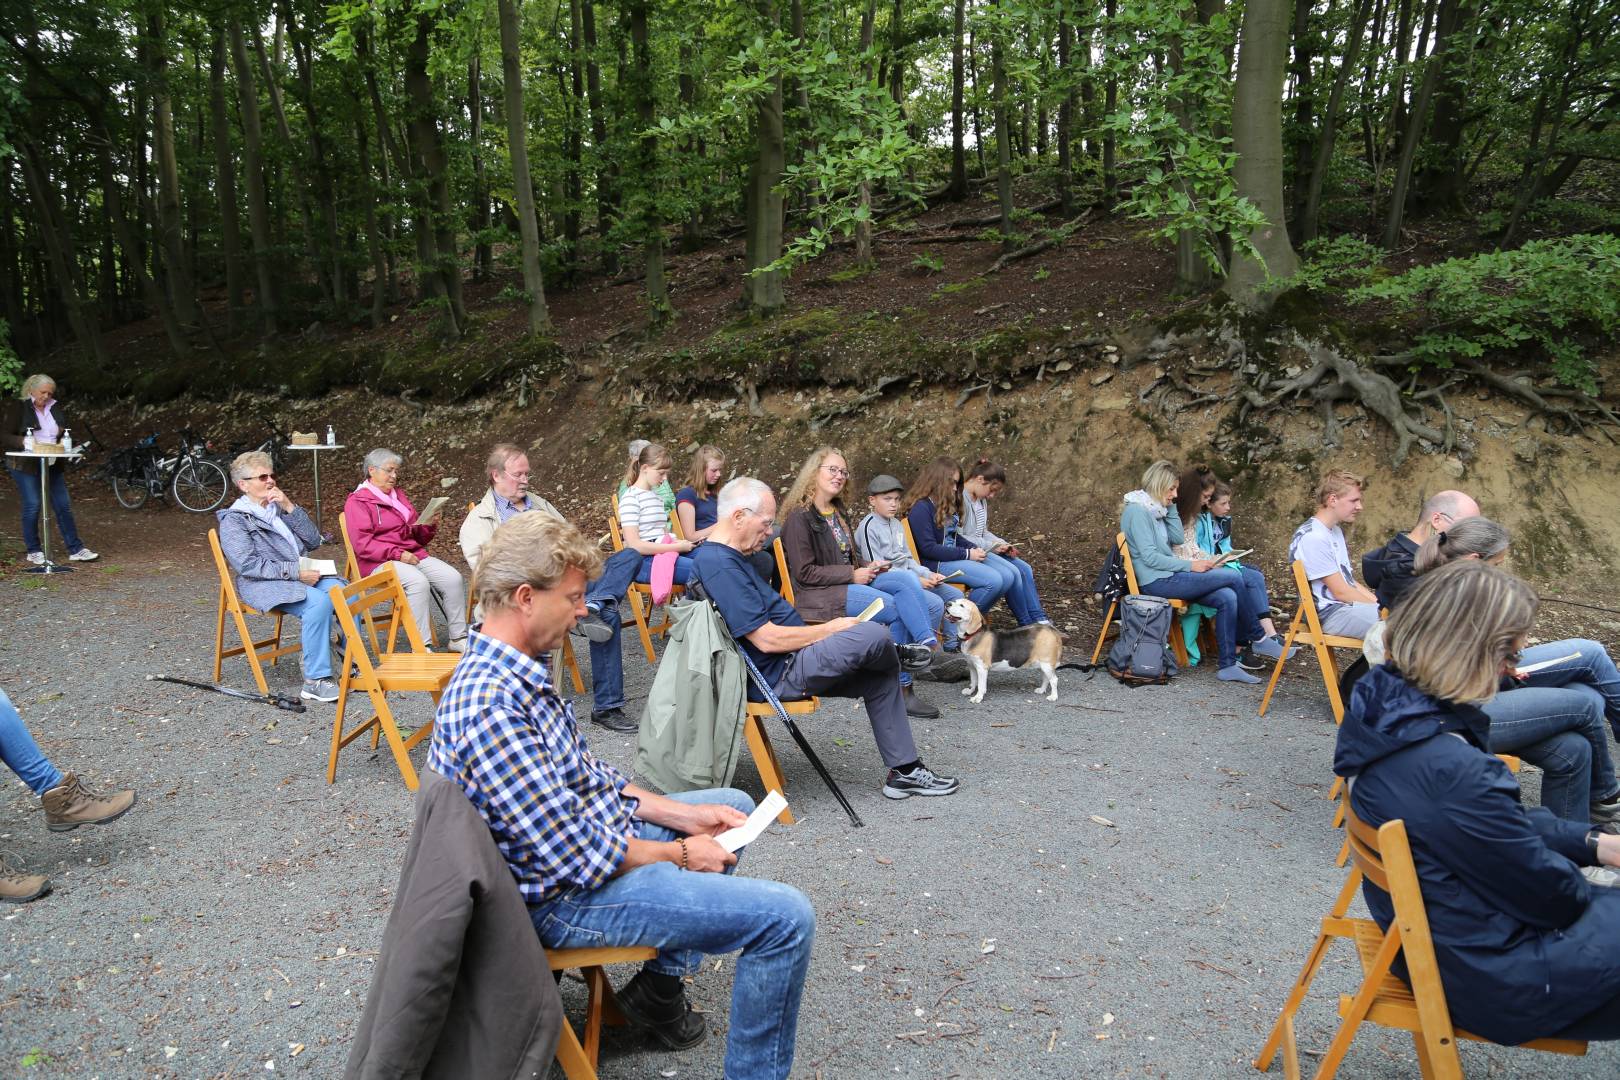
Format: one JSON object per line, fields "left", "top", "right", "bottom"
{"left": 326, "top": 565, "right": 462, "bottom": 792}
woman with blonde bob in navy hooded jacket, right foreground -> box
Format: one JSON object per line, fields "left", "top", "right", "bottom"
{"left": 1333, "top": 559, "right": 1620, "bottom": 1044}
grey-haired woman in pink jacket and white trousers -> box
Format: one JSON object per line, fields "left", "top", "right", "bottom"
{"left": 343, "top": 449, "right": 467, "bottom": 653}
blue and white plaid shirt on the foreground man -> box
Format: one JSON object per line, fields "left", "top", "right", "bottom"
{"left": 428, "top": 631, "right": 638, "bottom": 905}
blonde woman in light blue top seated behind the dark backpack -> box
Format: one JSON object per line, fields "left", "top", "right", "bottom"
{"left": 1119, "top": 461, "right": 1283, "bottom": 683}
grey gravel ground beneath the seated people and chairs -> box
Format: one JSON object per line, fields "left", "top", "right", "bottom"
{"left": 0, "top": 499, "right": 1620, "bottom": 1078}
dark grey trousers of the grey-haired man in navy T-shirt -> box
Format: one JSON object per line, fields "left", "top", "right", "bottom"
{"left": 776, "top": 622, "right": 917, "bottom": 769}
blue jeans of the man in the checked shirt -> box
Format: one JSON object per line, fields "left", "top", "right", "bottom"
{"left": 530, "top": 789, "right": 815, "bottom": 1080}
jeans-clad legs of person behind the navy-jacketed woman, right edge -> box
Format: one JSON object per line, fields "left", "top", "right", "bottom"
{"left": 1481, "top": 687, "right": 1620, "bottom": 824}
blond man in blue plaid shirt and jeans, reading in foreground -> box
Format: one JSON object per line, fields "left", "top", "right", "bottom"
{"left": 428, "top": 513, "right": 815, "bottom": 1080}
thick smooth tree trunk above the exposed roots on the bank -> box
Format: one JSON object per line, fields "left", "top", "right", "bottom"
{"left": 1226, "top": 0, "right": 1299, "bottom": 309}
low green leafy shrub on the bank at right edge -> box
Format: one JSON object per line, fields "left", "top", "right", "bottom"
{"left": 1349, "top": 235, "right": 1620, "bottom": 393}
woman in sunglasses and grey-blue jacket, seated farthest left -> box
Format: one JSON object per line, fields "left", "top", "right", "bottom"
{"left": 215, "top": 450, "right": 348, "bottom": 701}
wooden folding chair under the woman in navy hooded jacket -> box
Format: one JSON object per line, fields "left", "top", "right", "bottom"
{"left": 1254, "top": 798, "right": 1586, "bottom": 1080}
